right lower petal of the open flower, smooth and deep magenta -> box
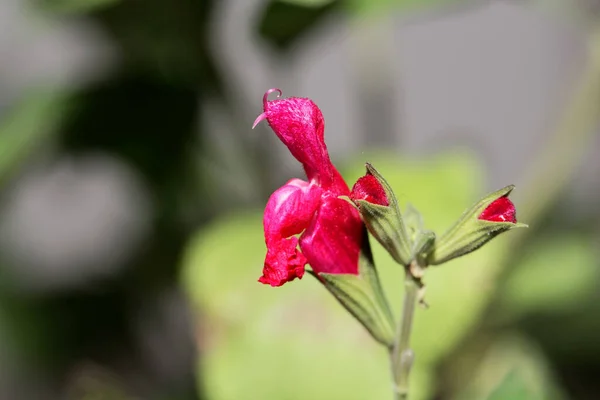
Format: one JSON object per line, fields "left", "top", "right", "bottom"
{"left": 300, "top": 197, "right": 363, "bottom": 274}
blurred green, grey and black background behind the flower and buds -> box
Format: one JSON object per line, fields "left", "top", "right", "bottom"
{"left": 0, "top": 0, "right": 600, "bottom": 400}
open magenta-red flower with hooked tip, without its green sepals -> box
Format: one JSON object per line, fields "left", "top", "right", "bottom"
{"left": 253, "top": 89, "right": 363, "bottom": 286}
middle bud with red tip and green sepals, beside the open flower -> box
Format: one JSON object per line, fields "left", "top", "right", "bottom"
{"left": 350, "top": 163, "right": 412, "bottom": 266}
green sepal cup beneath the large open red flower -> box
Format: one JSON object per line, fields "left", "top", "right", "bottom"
{"left": 314, "top": 231, "right": 394, "bottom": 348}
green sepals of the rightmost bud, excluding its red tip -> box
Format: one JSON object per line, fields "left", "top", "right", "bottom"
{"left": 427, "top": 185, "right": 527, "bottom": 265}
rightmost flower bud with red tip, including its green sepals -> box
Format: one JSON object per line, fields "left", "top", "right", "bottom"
{"left": 428, "top": 185, "right": 527, "bottom": 265}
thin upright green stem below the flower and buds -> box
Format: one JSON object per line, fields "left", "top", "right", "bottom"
{"left": 390, "top": 269, "right": 419, "bottom": 400}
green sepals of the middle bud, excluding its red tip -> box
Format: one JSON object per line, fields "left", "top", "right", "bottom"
{"left": 356, "top": 163, "right": 412, "bottom": 266}
